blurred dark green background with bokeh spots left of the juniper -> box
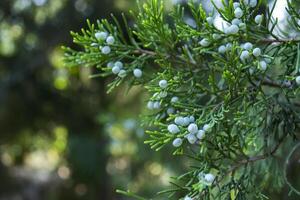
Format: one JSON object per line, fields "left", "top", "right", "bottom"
{"left": 0, "top": 0, "right": 300, "bottom": 200}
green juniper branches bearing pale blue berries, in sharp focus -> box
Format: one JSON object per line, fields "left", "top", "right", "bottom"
{"left": 64, "top": 0, "right": 300, "bottom": 199}
